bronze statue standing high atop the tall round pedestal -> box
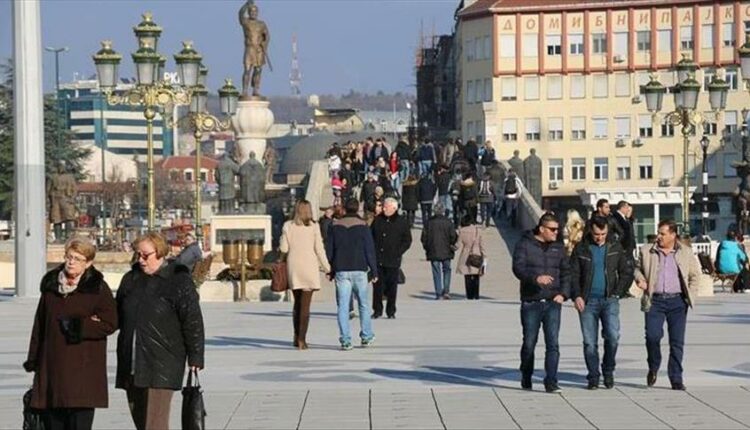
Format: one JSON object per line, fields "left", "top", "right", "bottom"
{"left": 239, "top": 0, "right": 273, "bottom": 97}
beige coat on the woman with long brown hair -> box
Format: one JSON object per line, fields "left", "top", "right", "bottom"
{"left": 279, "top": 221, "right": 331, "bottom": 290}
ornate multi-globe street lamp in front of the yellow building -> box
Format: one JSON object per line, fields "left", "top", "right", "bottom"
{"left": 641, "top": 62, "right": 728, "bottom": 234}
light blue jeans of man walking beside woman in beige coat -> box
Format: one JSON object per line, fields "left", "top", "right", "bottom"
{"left": 336, "top": 271, "right": 375, "bottom": 345}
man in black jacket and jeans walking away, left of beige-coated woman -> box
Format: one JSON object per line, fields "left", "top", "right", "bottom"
{"left": 421, "top": 203, "right": 458, "bottom": 300}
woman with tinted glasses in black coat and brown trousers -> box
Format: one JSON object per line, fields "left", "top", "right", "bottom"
{"left": 115, "top": 232, "right": 204, "bottom": 430}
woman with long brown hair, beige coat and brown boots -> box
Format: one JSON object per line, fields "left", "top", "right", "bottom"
{"left": 280, "top": 200, "right": 331, "bottom": 349}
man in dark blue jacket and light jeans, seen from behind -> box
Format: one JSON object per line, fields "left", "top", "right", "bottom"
{"left": 326, "top": 199, "right": 378, "bottom": 350}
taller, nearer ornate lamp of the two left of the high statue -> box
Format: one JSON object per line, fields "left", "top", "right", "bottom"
{"left": 93, "top": 13, "right": 202, "bottom": 230}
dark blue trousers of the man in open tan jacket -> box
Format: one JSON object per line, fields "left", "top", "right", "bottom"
{"left": 646, "top": 295, "right": 688, "bottom": 384}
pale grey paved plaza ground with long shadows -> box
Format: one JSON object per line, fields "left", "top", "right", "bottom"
{"left": 0, "top": 225, "right": 750, "bottom": 429}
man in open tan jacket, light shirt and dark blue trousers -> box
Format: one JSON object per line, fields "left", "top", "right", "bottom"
{"left": 635, "top": 219, "right": 701, "bottom": 390}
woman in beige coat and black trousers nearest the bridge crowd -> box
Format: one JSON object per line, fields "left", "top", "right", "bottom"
{"left": 458, "top": 215, "right": 485, "bottom": 300}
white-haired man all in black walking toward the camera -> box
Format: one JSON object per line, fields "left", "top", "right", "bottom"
{"left": 371, "top": 197, "right": 411, "bottom": 318}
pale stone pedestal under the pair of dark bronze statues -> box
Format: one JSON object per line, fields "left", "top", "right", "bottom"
{"left": 211, "top": 215, "right": 272, "bottom": 254}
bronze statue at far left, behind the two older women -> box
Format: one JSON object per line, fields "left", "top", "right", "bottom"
{"left": 47, "top": 163, "right": 77, "bottom": 243}
